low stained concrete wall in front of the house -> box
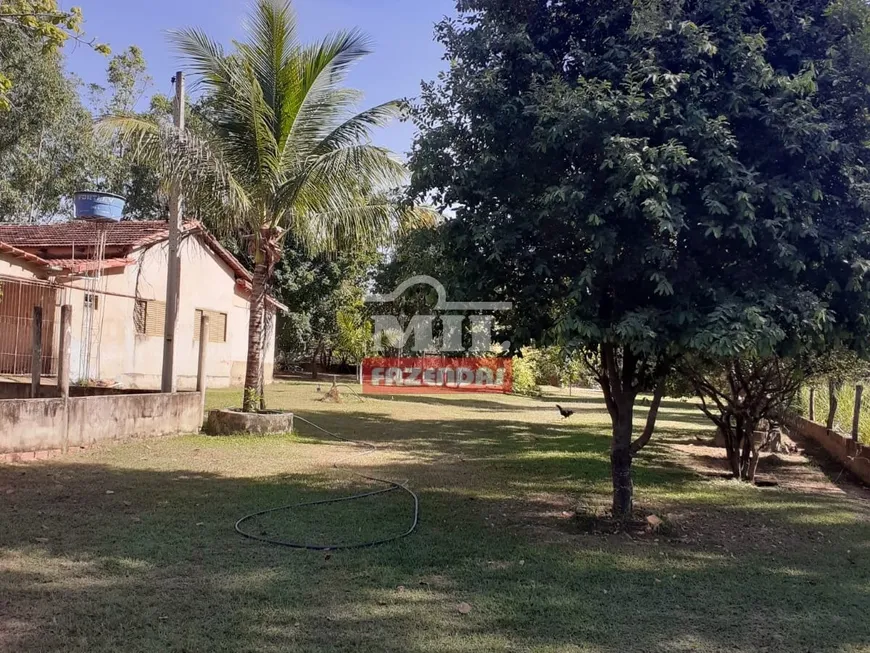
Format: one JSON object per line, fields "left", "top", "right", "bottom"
{"left": 0, "top": 392, "right": 202, "bottom": 454}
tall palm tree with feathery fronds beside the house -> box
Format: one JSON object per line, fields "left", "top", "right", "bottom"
{"left": 100, "top": 0, "right": 426, "bottom": 411}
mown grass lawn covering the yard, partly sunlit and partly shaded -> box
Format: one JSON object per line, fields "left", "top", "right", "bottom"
{"left": 0, "top": 384, "right": 870, "bottom": 653}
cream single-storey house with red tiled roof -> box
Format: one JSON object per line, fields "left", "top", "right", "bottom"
{"left": 0, "top": 221, "right": 286, "bottom": 389}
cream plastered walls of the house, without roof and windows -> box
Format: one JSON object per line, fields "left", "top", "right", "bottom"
{"left": 0, "top": 236, "right": 275, "bottom": 390}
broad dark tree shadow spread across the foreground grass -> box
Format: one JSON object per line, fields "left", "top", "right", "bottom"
{"left": 0, "top": 449, "right": 870, "bottom": 652}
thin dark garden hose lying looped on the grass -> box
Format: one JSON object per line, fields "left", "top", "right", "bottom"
{"left": 236, "top": 415, "right": 420, "bottom": 551}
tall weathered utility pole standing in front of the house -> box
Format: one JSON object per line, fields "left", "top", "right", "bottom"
{"left": 160, "top": 71, "right": 185, "bottom": 392}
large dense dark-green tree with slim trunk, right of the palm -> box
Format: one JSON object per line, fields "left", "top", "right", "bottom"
{"left": 412, "top": 0, "right": 870, "bottom": 515}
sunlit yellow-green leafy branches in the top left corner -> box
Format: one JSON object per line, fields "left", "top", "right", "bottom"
{"left": 0, "top": 0, "right": 110, "bottom": 112}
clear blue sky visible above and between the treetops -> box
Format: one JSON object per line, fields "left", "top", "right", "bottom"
{"left": 61, "top": 0, "right": 455, "bottom": 154}
